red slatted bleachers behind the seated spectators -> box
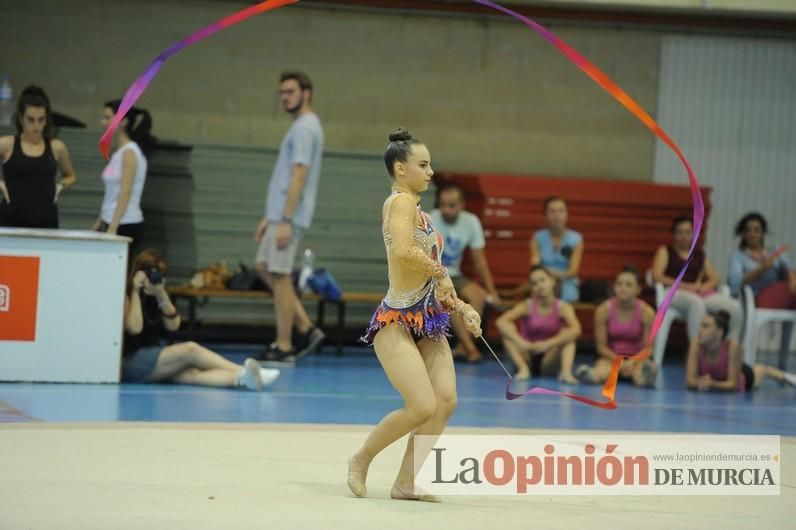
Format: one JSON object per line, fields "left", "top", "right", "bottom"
{"left": 437, "top": 173, "right": 711, "bottom": 337}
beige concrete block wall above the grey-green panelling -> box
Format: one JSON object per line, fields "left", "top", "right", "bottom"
{"left": 0, "top": 0, "right": 661, "bottom": 180}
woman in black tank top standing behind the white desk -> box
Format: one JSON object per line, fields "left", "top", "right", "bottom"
{"left": 0, "top": 86, "right": 77, "bottom": 228}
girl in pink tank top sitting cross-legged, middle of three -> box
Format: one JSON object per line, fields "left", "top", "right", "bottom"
{"left": 575, "top": 267, "right": 658, "bottom": 387}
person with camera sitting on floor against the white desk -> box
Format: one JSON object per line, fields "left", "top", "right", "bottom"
{"left": 122, "top": 250, "right": 279, "bottom": 390}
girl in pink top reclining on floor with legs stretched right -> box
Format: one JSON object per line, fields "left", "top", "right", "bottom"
{"left": 686, "top": 311, "right": 796, "bottom": 392}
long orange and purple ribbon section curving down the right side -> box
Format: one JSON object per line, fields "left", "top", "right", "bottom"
{"left": 473, "top": 0, "right": 705, "bottom": 409}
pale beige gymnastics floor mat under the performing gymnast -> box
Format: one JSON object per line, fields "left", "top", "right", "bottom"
{"left": 0, "top": 423, "right": 796, "bottom": 530}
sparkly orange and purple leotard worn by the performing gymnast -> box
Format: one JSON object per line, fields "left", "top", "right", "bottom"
{"left": 361, "top": 192, "right": 450, "bottom": 344}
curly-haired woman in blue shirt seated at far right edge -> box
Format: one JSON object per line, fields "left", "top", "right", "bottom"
{"left": 728, "top": 212, "right": 796, "bottom": 309}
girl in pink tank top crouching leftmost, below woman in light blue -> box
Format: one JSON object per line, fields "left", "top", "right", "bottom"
{"left": 497, "top": 265, "right": 581, "bottom": 384}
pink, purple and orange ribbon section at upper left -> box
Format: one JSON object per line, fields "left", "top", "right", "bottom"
{"left": 99, "top": 0, "right": 298, "bottom": 160}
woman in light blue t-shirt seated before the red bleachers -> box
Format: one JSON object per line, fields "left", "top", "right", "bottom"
{"left": 504, "top": 197, "right": 583, "bottom": 302}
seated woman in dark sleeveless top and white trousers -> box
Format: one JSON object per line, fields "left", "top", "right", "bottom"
{"left": 652, "top": 216, "right": 743, "bottom": 339}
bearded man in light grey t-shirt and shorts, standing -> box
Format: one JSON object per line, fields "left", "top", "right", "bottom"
{"left": 254, "top": 72, "right": 324, "bottom": 361}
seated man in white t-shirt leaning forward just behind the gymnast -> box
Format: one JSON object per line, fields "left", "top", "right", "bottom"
{"left": 431, "top": 184, "right": 500, "bottom": 362}
